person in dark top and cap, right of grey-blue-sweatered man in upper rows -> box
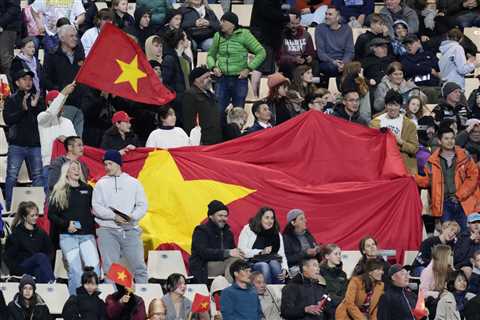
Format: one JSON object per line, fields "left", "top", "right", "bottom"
{"left": 354, "top": 13, "right": 390, "bottom": 61}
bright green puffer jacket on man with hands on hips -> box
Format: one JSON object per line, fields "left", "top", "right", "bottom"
{"left": 207, "top": 28, "right": 266, "bottom": 76}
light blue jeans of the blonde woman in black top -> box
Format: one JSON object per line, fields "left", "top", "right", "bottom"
{"left": 60, "top": 233, "right": 100, "bottom": 295}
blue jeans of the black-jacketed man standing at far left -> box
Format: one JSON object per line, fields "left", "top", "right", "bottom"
{"left": 5, "top": 145, "right": 43, "bottom": 209}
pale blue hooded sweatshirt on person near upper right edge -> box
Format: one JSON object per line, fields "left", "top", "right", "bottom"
{"left": 438, "top": 40, "right": 475, "bottom": 89}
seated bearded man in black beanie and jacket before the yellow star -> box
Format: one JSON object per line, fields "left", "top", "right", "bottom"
{"left": 190, "top": 200, "right": 244, "bottom": 284}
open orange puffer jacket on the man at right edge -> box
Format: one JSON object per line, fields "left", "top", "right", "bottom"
{"left": 415, "top": 147, "right": 480, "bottom": 217}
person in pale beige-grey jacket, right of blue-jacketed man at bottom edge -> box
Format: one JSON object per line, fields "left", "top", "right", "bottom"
{"left": 250, "top": 271, "right": 282, "bottom": 320}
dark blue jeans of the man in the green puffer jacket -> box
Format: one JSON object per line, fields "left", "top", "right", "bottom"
{"left": 215, "top": 76, "right": 248, "bottom": 123}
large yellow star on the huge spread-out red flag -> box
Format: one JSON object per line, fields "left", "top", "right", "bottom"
{"left": 138, "top": 150, "right": 256, "bottom": 253}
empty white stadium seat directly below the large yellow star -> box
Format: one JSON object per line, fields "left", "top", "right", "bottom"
{"left": 147, "top": 250, "right": 187, "bottom": 280}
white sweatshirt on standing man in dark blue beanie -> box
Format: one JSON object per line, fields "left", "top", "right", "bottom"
{"left": 92, "top": 172, "right": 147, "bottom": 230}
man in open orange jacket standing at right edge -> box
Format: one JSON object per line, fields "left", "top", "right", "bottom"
{"left": 415, "top": 128, "right": 480, "bottom": 231}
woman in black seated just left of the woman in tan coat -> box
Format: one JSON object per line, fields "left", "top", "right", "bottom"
{"left": 320, "top": 243, "right": 347, "bottom": 316}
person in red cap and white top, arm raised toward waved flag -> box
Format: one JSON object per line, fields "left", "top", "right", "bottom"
{"left": 37, "top": 83, "right": 77, "bottom": 195}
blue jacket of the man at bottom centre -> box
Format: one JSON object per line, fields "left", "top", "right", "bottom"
{"left": 220, "top": 283, "right": 263, "bottom": 320}
